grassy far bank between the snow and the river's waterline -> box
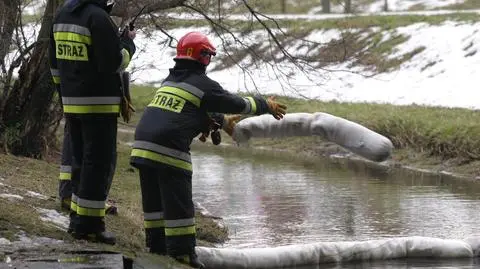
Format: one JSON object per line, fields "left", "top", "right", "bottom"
{"left": 132, "top": 86, "right": 480, "bottom": 177}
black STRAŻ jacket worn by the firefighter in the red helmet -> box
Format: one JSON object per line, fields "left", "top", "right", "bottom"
{"left": 130, "top": 60, "right": 269, "bottom": 171}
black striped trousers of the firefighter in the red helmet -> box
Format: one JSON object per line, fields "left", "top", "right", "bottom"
{"left": 138, "top": 165, "right": 196, "bottom": 257}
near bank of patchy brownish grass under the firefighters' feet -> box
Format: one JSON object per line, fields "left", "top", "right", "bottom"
{"left": 0, "top": 138, "right": 227, "bottom": 268}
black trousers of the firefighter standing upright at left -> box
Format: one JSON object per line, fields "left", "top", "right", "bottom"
{"left": 65, "top": 115, "right": 117, "bottom": 233}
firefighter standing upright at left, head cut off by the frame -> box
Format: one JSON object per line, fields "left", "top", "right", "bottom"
{"left": 49, "top": 0, "right": 135, "bottom": 244}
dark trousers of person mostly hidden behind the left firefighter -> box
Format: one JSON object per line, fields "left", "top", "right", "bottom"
{"left": 58, "top": 122, "right": 117, "bottom": 207}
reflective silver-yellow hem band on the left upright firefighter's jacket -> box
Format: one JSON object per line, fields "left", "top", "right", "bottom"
{"left": 62, "top": 96, "right": 120, "bottom": 114}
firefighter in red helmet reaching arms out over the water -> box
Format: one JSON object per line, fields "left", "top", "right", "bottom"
{"left": 130, "top": 32, "right": 286, "bottom": 268}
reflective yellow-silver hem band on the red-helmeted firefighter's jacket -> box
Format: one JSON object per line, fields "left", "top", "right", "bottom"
{"left": 131, "top": 140, "right": 192, "bottom": 171}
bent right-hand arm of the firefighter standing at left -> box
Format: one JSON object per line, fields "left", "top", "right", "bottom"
{"left": 90, "top": 12, "right": 135, "bottom": 73}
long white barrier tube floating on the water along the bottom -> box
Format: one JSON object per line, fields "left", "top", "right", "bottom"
{"left": 196, "top": 236, "right": 480, "bottom": 269}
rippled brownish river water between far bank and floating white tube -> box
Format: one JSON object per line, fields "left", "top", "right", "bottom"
{"left": 192, "top": 147, "right": 480, "bottom": 268}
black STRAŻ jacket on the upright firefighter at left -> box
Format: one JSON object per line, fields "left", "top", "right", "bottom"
{"left": 49, "top": 0, "right": 135, "bottom": 114}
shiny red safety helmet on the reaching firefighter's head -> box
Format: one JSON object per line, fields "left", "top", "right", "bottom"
{"left": 174, "top": 32, "right": 217, "bottom": 66}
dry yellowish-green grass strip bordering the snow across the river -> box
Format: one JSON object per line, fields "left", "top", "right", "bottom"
{"left": 130, "top": 86, "right": 480, "bottom": 161}
